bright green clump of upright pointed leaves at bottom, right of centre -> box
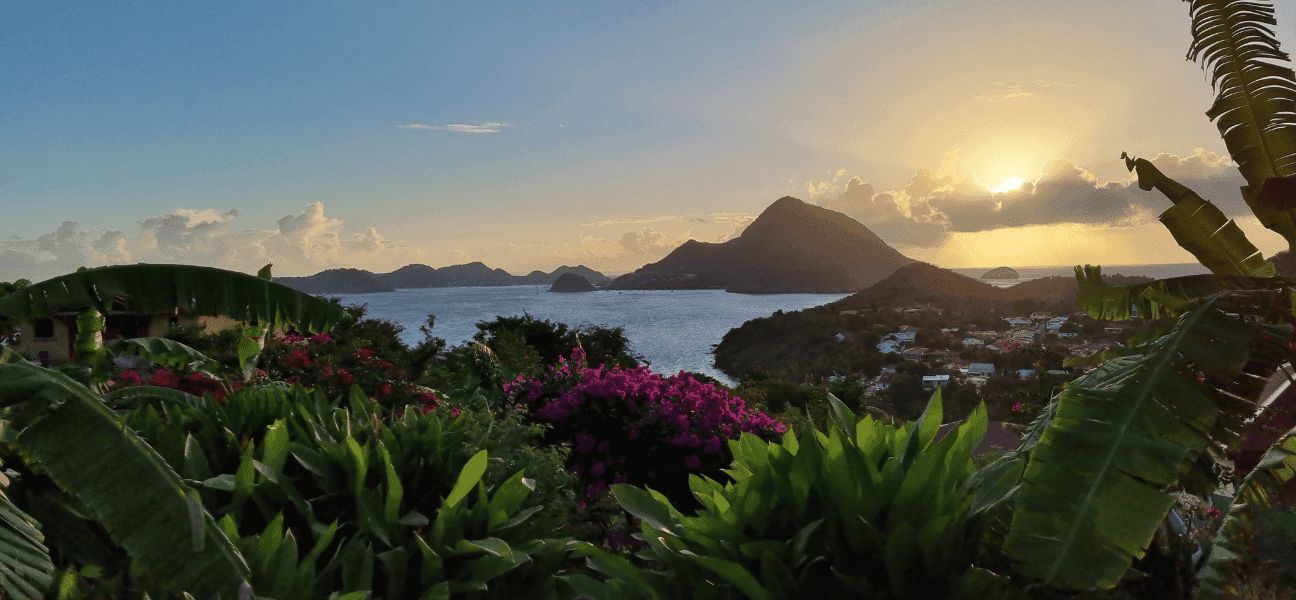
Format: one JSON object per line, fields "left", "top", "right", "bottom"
{"left": 568, "top": 394, "right": 1012, "bottom": 599}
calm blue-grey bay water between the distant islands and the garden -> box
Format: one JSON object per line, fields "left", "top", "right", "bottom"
{"left": 331, "top": 287, "right": 850, "bottom": 382}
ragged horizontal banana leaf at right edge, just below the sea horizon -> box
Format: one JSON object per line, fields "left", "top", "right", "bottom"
{"left": 1076, "top": 264, "right": 1296, "bottom": 320}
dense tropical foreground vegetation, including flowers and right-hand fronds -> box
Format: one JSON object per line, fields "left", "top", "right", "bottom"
{"left": 0, "top": 1, "right": 1296, "bottom": 600}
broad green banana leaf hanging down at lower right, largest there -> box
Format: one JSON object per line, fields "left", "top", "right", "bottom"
{"left": 1003, "top": 294, "right": 1292, "bottom": 590}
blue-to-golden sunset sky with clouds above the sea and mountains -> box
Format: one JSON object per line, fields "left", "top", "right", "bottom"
{"left": 0, "top": 0, "right": 1296, "bottom": 281}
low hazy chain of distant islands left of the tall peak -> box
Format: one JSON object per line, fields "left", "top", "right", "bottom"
{"left": 275, "top": 262, "right": 612, "bottom": 294}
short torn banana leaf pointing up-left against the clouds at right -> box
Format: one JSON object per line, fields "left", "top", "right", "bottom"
{"left": 1121, "top": 153, "right": 1278, "bottom": 277}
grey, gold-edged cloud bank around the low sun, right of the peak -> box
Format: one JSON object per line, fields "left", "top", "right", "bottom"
{"left": 807, "top": 148, "right": 1251, "bottom": 248}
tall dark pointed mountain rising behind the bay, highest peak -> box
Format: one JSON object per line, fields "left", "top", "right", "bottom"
{"left": 609, "top": 196, "right": 914, "bottom": 294}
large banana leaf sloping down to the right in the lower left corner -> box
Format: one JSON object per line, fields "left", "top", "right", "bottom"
{"left": 0, "top": 363, "right": 249, "bottom": 597}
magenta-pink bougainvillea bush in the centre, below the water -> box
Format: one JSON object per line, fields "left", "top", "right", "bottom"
{"left": 504, "top": 347, "right": 787, "bottom": 507}
